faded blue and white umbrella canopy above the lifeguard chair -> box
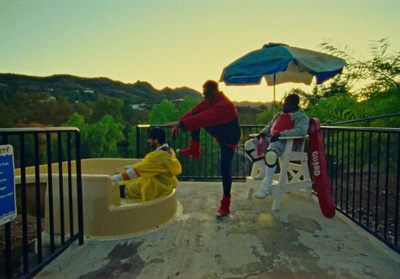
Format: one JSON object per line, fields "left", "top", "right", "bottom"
{"left": 220, "top": 43, "right": 347, "bottom": 92}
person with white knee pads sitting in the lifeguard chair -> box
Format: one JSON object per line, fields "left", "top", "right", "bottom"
{"left": 244, "top": 94, "right": 309, "bottom": 199}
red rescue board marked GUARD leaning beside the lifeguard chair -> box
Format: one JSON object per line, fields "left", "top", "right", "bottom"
{"left": 308, "top": 118, "right": 335, "bottom": 218}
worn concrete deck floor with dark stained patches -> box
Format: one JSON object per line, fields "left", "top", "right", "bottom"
{"left": 35, "top": 182, "right": 400, "bottom": 279}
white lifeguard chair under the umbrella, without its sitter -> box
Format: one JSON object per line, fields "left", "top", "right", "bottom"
{"left": 246, "top": 136, "right": 312, "bottom": 210}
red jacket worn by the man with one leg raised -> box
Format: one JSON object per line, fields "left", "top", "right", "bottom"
{"left": 179, "top": 92, "right": 238, "bottom": 131}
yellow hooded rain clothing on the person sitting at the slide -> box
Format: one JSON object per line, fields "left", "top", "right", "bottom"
{"left": 120, "top": 148, "right": 182, "bottom": 202}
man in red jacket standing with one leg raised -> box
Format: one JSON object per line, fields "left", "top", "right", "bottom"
{"left": 165, "top": 80, "right": 241, "bottom": 217}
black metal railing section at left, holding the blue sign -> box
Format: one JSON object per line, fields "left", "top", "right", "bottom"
{"left": 0, "top": 128, "right": 84, "bottom": 278}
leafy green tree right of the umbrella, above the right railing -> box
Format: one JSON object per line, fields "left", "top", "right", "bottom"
{"left": 306, "top": 38, "right": 400, "bottom": 127}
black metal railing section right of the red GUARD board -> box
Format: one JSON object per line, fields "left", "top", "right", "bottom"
{"left": 323, "top": 126, "right": 400, "bottom": 252}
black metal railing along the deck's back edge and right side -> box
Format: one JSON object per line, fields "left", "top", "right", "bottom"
{"left": 136, "top": 125, "right": 400, "bottom": 252}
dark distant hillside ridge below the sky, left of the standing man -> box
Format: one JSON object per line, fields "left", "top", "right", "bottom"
{"left": 0, "top": 74, "right": 201, "bottom": 104}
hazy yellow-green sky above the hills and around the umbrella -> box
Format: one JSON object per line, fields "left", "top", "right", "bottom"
{"left": 0, "top": 0, "right": 400, "bottom": 102}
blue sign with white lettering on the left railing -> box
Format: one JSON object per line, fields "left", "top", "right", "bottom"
{"left": 0, "top": 145, "right": 17, "bottom": 226}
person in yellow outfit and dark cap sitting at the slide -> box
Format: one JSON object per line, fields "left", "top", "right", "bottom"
{"left": 111, "top": 128, "right": 182, "bottom": 202}
